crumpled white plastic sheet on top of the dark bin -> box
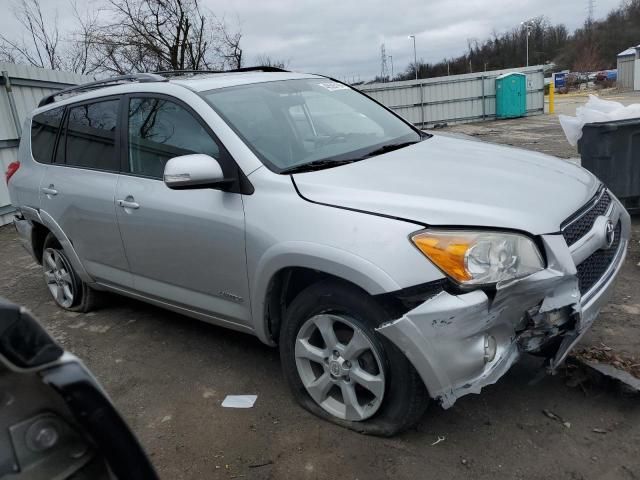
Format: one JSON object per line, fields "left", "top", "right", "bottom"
{"left": 558, "top": 95, "right": 640, "bottom": 147}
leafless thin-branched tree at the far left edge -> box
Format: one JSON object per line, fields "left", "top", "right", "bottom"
{"left": 0, "top": 0, "right": 63, "bottom": 69}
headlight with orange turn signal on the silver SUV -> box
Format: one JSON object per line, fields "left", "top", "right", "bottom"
{"left": 411, "top": 229, "right": 544, "bottom": 285}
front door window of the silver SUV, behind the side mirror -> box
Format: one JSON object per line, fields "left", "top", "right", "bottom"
{"left": 128, "top": 97, "right": 224, "bottom": 179}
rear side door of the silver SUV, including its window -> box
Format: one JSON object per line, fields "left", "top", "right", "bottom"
{"left": 40, "top": 97, "right": 132, "bottom": 287}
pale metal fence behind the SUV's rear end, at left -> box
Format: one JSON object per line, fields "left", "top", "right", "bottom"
{"left": 0, "top": 62, "right": 94, "bottom": 225}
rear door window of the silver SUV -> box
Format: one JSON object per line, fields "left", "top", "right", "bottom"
{"left": 64, "top": 99, "right": 120, "bottom": 172}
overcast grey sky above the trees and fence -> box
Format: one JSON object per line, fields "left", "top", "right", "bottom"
{"left": 0, "top": 0, "right": 620, "bottom": 81}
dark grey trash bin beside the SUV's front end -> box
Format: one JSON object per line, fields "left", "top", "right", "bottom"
{"left": 578, "top": 118, "right": 640, "bottom": 213}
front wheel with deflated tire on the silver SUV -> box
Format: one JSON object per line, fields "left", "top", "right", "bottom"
{"left": 280, "top": 281, "right": 429, "bottom": 436}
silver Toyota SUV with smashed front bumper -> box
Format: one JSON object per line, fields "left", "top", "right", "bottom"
{"left": 7, "top": 69, "right": 629, "bottom": 435}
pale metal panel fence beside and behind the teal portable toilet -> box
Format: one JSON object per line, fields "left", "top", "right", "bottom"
{"left": 358, "top": 66, "right": 544, "bottom": 128}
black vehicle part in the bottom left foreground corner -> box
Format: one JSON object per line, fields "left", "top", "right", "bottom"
{"left": 0, "top": 298, "right": 158, "bottom": 480}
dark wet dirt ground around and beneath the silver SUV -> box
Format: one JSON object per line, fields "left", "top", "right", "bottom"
{"left": 0, "top": 103, "right": 640, "bottom": 480}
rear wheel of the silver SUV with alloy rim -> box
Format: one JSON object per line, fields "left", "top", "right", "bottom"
{"left": 42, "top": 233, "right": 96, "bottom": 313}
